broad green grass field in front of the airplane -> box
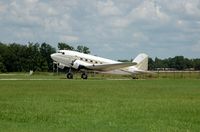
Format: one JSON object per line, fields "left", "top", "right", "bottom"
{"left": 0, "top": 79, "right": 200, "bottom": 132}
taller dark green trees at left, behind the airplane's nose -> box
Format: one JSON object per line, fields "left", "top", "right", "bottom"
{"left": 0, "top": 42, "right": 90, "bottom": 72}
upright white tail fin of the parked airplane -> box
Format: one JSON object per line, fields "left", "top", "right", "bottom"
{"left": 133, "top": 53, "right": 148, "bottom": 71}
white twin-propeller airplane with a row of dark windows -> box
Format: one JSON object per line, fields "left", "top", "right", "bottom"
{"left": 51, "top": 50, "right": 148, "bottom": 79}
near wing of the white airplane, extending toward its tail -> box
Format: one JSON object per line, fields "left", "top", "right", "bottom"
{"left": 85, "top": 62, "right": 137, "bottom": 71}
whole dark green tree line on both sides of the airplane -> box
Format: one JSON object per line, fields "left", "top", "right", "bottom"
{"left": 0, "top": 42, "right": 200, "bottom": 72}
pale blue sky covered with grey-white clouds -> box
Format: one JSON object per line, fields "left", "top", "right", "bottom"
{"left": 0, "top": 0, "right": 200, "bottom": 59}
